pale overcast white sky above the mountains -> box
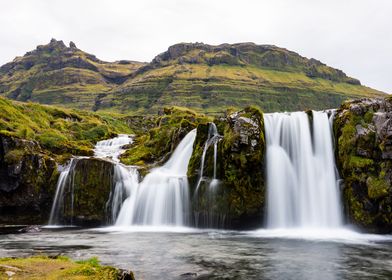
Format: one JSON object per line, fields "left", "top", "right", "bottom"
{"left": 0, "top": 0, "right": 392, "bottom": 93}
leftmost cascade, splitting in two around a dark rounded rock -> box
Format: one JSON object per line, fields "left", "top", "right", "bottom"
{"left": 49, "top": 134, "right": 139, "bottom": 225}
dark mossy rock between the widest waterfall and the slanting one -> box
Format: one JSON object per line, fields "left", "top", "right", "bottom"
{"left": 188, "top": 107, "right": 265, "bottom": 228}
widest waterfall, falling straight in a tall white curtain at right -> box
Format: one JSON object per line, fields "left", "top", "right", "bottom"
{"left": 264, "top": 111, "right": 342, "bottom": 228}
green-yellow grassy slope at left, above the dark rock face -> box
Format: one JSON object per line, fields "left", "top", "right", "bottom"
{"left": 0, "top": 97, "right": 131, "bottom": 158}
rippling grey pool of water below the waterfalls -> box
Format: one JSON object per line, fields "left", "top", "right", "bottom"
{"left": 0, "top": 227, "right": 392, "bottom": 280}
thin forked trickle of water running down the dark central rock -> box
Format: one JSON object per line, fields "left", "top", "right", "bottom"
{"left": 195, "top": 122, "right": 222, "bottom": 193}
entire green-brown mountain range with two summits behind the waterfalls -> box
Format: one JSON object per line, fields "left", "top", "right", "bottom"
{"left": 0, "top": 39, "right": 384, "bottom": 114}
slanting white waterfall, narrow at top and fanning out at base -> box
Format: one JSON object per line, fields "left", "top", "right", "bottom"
{"left": 116, "top": 129, "right": 196, "bottom": 226}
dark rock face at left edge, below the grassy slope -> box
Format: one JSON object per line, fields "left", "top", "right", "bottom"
{"left": 0, "top": 133, "right": 58, "bottom": 224}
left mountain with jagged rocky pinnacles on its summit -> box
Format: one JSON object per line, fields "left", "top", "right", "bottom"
{"left": 0, "top": 39, "right": 144, "bottom": 109}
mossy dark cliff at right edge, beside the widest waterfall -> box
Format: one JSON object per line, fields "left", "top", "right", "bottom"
{"left": 334, "top": 98, "right": 392, "bottom": 233}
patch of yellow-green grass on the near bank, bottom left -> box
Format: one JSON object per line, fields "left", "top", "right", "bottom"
{"left": 0, "top": 256, "right": 133, "bottom": 280}
